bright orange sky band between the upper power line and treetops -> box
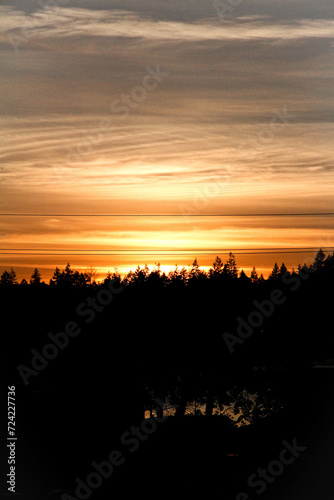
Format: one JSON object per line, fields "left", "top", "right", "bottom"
{"left": 1, "top": 216, "right": 334, "bottom": 280}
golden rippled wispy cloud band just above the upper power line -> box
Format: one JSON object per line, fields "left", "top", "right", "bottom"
{"left": 0, "top": 116, "right": 333, "bottom": 213}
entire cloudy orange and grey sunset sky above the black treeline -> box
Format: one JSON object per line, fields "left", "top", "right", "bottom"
{"left": 0, "top": 0, "right": 334, "bottom": 279}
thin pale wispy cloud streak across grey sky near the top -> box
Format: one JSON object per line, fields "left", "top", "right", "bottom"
{"left": 0, "top": 6, "right": 334, "bottom": 46}
